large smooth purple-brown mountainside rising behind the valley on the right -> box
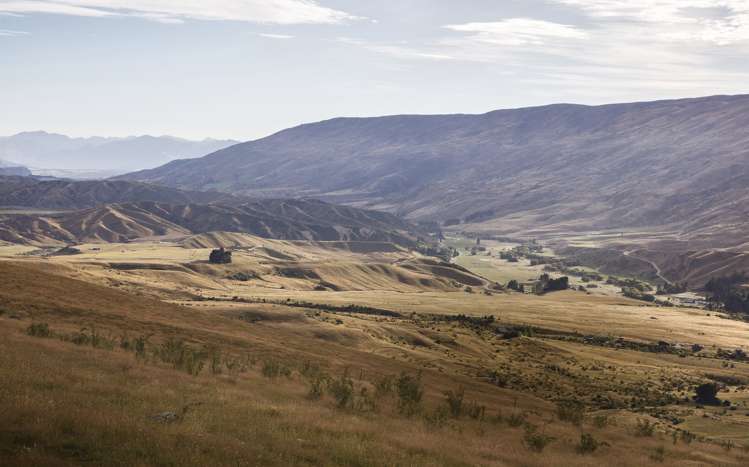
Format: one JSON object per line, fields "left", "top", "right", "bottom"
{"left": 124, "top": 96, "right": 749, "bottom": 249}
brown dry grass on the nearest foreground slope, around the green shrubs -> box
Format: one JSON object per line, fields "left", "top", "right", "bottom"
{"left": 0, "top": 263, "right": 747, "bottom": 466}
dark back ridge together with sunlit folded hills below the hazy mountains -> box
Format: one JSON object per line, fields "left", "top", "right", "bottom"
{"left": 0, "top": 177, "right": 416, "bottom": 246}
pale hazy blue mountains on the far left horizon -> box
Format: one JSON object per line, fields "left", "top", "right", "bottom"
{"left": 0, "top": 131, "right": 237, "bottom": 178}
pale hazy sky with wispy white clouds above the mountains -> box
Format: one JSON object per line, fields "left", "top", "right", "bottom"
{"left": 0, "top": 0, "right": 749, "bottom": 140}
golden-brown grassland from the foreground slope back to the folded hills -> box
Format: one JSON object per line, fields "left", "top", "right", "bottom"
{"left": 0, "top": 234, "right": 749, "bottom": 466}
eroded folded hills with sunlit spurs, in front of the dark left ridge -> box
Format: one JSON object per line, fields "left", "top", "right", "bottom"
{"left": 0, "top": 200, "right": 414, "bottom": 245}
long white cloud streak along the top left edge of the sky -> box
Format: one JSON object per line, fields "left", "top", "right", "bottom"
{"left": 0, "top": 0, "right": 357, "bottom": 24}
